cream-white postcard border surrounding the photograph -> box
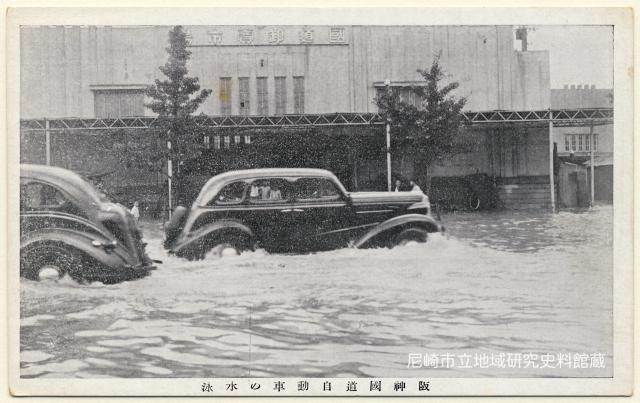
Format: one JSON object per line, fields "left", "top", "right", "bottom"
{"left": 3, "top": 6, "right": 634, "bottom": 396}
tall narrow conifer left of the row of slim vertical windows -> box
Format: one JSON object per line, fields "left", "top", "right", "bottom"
{"left": 145, "top": 25, "right": 211, "bottom": 205}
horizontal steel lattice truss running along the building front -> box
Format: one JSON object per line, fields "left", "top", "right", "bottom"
{"left": 20, "top": 108, "right": 613, "bottom": 132}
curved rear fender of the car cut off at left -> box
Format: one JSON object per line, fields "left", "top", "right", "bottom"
{"left": 20, "top": 228, "right": 132, "bottom": 268}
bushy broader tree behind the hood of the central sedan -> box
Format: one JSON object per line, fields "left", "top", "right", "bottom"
{"left": 375, "top": 55, "right": 467, "bottom": 191}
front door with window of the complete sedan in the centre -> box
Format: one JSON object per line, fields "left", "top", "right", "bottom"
{"left": 291, "top": 177, "right": 355, "bottom": 250}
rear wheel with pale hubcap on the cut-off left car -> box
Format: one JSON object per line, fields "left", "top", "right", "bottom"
{"left": 20, "top": 245, "right": 83, "bottom": 281}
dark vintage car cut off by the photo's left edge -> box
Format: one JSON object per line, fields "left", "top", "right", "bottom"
{"left": 20, "top": 164, "right": 154, "bottom": 283}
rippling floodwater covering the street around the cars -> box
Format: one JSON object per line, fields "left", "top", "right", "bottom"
{"left": 20, "top": 207, "right": 613, "bottom": 378}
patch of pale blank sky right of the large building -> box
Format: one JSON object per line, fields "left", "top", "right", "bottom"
{"left": 527, "top": 25, "right": 613, "bottom": 88}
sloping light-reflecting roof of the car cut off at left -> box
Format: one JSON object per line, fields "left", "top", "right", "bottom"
{"left": 20, "top": 164, "right": 100, "bottom": 202}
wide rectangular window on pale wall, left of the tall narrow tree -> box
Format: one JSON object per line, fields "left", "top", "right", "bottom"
{"left": 94, "top": 89, "right": 144, "bottom": 118}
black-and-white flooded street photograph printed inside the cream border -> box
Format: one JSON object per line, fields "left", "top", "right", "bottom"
{"left": 10, "top": 5, "right": 632, "bottom": 396}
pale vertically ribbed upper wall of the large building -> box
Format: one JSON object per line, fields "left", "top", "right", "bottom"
{"left": 21, "top": 26, "right": 550, "bottom": 118}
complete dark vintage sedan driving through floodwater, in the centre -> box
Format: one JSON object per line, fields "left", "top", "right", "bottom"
{"left": 165, "top": 168, "right": 444, "bottom": 259}
